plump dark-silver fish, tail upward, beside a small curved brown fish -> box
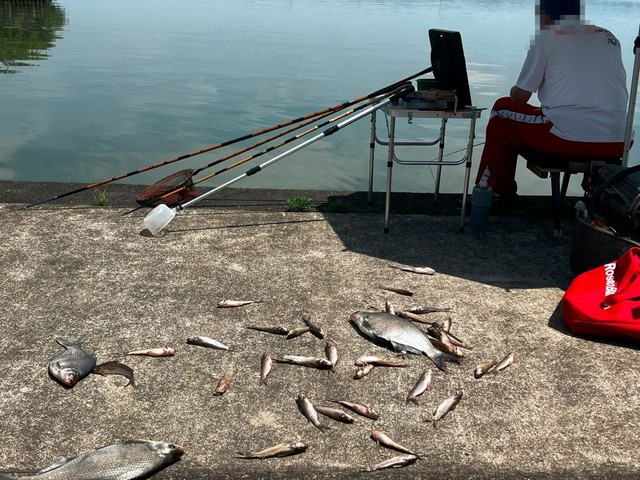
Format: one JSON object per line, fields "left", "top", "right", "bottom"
{"left": 49, "top": 336, "right": 96, "bottom": 388}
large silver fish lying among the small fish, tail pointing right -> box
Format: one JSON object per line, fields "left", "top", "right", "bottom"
{"left": 350, "top": 312, "right": 458, "bottom": 370}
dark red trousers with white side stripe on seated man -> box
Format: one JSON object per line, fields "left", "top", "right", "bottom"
{"left": 476, "top": 97, "right": 624, "bottom": 195}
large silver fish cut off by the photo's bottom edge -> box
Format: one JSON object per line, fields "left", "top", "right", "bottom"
{"left": 21, "top": 440, "right": 184, "bottom": 480}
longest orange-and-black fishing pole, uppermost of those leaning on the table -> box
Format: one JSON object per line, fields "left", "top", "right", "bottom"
{"left": 24, "top": 67, "right": 433, "bottom": 208}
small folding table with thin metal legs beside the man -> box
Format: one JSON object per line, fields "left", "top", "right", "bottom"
{"left": 368, "top": 105, "right": 482, "bottom": 233}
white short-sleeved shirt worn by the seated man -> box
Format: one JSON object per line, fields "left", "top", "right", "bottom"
{"left": 516, "top": 20, "right": 628, "bottom": 142}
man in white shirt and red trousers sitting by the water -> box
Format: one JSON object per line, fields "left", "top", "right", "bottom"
{"left": 476, "top": 0, "right": 628, "bottom": 200}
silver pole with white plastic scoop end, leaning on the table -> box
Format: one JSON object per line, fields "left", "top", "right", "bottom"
{"left": 143, "top": 84, "right": 415, "bottom": 235}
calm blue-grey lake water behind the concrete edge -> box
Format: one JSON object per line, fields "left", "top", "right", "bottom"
{"left": 0, "top": 0, "right": 640, "bottom": 194}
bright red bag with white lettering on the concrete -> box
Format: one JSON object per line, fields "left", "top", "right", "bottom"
{"left": 562, "top": 247, "right": 640, "bottom": 340}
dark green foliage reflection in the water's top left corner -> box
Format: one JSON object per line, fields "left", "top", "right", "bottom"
{"left": 0, "top": 0, "right": 66, "bottom": 73}
